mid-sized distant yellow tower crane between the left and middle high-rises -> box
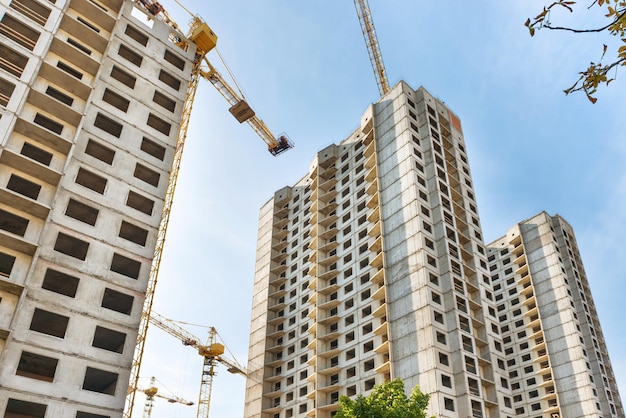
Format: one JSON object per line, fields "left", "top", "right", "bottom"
{"left": 150, "top": 311, "right": 247, "bottom": 418}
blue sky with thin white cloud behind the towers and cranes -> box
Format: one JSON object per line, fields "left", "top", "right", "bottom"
{"left": 129, "top": 0, "right": 626, "bottom": 418}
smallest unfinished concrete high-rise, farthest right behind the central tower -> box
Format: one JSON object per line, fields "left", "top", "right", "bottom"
{"left": 489, "top": 212, "right": 624, "bottom": 418}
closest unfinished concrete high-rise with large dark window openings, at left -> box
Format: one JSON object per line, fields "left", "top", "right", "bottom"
{"left": 0, "top": 0, "right": 195, "bottom": 418}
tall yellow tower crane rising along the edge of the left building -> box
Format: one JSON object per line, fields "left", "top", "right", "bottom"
{"left": 123, "top": 0, "right": 294, "bottom": 418}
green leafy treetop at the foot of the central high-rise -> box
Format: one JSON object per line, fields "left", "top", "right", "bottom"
{"left": 335, "top": 379, "right": 429, "bottom": 418}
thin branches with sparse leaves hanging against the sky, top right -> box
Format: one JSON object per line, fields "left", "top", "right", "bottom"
{"left": 525, "top": 0, "right": 626, "bottom": 103}
